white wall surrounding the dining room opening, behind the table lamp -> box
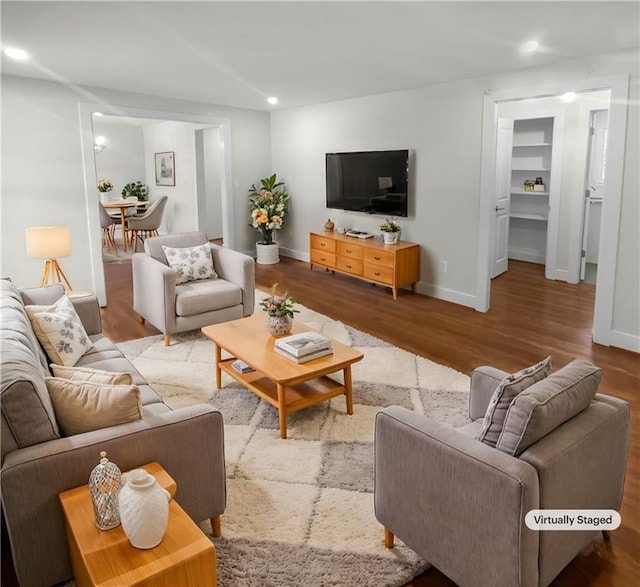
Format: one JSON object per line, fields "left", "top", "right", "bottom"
{"left": 1, "top": 76, "right": 271, "bottom": 290}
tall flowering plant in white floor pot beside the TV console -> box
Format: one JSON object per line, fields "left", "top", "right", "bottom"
{"left": 249, "top": 173, "right": 289, "bottom": 265}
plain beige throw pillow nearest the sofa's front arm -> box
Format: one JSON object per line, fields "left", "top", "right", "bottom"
{"left": 45, "top": 377, "right": 142, "bottom": 436}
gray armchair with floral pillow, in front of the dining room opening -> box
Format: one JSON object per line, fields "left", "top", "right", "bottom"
{"left": 132, "top": 232, "right": 255, "bottom": 346}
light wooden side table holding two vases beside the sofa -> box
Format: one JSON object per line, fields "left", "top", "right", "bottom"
{"left": 59, "top": 463, "right": 217, "bottom": 587}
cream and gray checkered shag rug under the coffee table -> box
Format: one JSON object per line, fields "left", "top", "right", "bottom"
{"left": 118, "top": 292, "right": 469, "bottom": 587}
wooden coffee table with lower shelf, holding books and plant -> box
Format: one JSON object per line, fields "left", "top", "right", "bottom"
{"left": 202, "top": 314, "right": 364, "bottom": 438}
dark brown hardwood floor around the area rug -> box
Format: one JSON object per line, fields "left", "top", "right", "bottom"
{"left": 5, "top": 258, "right": 640, "bottom": 587}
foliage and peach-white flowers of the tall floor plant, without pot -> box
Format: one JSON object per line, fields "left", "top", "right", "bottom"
{"left": 249, "top": 173, "right": 289, "bottom": 245}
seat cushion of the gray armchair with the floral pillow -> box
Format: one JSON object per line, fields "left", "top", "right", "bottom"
{"left": 176, "top": 279, "right": 242, "bottom": 317}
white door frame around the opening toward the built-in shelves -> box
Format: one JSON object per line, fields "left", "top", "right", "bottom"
{"left": 475, "top": 74, "right": 629, "bottom": 346}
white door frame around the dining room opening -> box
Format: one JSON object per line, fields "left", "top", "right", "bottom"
{"left": 78, "top": 102, "right": 235, "bottom": 306}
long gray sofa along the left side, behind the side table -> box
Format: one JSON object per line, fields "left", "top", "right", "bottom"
{"left": 0, "top": 280, "right": 226, "bottom": 586}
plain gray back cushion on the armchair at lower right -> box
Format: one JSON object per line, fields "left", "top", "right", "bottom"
{"left": 496, "top": 359, "right": 602, "bottom": 456}
